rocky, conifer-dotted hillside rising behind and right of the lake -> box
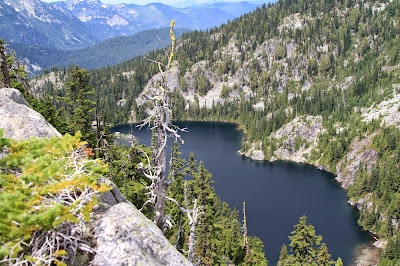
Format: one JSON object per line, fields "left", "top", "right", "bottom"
{"left": 35, "top": 0, "right": 400, "bottom": 265}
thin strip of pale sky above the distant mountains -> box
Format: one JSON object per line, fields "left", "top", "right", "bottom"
{"left": 42, "top": 0, "right": 267, "bottom": 7}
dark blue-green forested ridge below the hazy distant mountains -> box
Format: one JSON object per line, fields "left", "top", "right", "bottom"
{"left": 9, "top": 28, "right": 189, "bottom": 73}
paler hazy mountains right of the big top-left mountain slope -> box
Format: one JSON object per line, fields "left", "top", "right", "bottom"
{"left": 53, "top": 0, "right": 257, "bottom": 40}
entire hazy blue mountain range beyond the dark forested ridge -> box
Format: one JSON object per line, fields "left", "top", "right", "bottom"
{"left": 0, "top": 0, "right": 257, "bottom": 50}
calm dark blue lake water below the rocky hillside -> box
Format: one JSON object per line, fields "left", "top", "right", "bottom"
{"left": 113, "top": 122, "right": 372, "bottom": 265}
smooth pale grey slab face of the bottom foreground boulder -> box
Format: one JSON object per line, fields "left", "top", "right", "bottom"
{"left": 91, "top": 203, "right": 192, "bottom": 266}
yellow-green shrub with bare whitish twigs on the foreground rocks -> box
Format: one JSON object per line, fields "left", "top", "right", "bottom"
{"left": 0, "top": 134, "right": 107, "bottom": 264}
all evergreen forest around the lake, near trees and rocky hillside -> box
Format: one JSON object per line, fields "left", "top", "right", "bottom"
{"left": 0, "top": 0, "right": 400, "bottom": 265}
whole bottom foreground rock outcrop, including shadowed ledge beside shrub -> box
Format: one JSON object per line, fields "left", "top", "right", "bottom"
{"left": 84, "top": 178, "right": 192, "bottom": 266}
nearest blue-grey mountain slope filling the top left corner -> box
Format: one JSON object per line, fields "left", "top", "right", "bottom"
{"left": 0, "top": 0, "right": 98, "bottom": 50}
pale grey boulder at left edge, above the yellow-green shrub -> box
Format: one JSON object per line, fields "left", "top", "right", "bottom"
{"left": 0, "top": 88, "right": 61, "bottom": 140}
